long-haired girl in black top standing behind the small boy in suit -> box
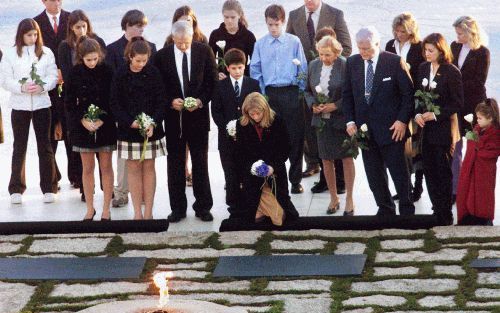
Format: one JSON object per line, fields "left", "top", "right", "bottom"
{"left": 208, "top": 0, "right": 256, "bottom": 79}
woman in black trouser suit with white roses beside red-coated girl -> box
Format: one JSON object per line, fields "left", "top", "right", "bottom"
{"left": 415, "top": 33, "right": 464, "bottom": 225}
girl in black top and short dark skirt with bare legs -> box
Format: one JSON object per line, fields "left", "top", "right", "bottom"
{"left": 65, "top": 36, "right": 116, "bottom": 221}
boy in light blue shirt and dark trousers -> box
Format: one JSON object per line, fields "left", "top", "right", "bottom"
{"left": 250, "top": 4, "right": 307, "bottom": 193}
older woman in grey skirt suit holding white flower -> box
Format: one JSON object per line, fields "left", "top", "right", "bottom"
{"left": 305, "top": 36, "right": 355, "bottom": 215}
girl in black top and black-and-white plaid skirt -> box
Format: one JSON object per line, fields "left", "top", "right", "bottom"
{"left": 110, "top": 37, "right": 167, "bottom": 220}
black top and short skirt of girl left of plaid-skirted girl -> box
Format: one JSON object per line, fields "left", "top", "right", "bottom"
{"left": 64, "top": 63, "right": 116, "bottom": 148}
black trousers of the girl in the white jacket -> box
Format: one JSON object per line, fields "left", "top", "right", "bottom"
{"left": 9, "top": 108, "right": 57, "bottom": 194}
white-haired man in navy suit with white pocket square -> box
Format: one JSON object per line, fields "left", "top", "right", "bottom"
{"left": 342, "top": 26, "right": 415, "bottom": 215}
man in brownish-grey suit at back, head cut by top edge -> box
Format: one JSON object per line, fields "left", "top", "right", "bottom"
{"left": 286, "top": 0, "right": 352, "bottom": 193}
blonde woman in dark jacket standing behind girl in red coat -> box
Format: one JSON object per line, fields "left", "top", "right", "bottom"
{"left": 451, "top": 16, "right": 490, "bottom": 199}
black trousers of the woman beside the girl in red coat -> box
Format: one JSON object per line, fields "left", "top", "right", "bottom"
{"left": 422, "top": 141, "right": 453, "bottom": 225}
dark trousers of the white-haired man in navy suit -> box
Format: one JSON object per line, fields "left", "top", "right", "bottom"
{"left": 362, "top": 140, "right": 415, "bottom": 215}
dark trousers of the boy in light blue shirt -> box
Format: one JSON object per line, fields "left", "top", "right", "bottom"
{"left": 266, "top": 86, "right": 304, "bottom": 184}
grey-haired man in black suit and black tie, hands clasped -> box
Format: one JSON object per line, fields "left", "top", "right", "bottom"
{"left": 154, "top": 21, "right": 217, "bottom": 223}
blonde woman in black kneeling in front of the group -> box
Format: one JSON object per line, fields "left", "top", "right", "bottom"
{"left": 236, "top": 92, "right": 299, "bottom": 222}
